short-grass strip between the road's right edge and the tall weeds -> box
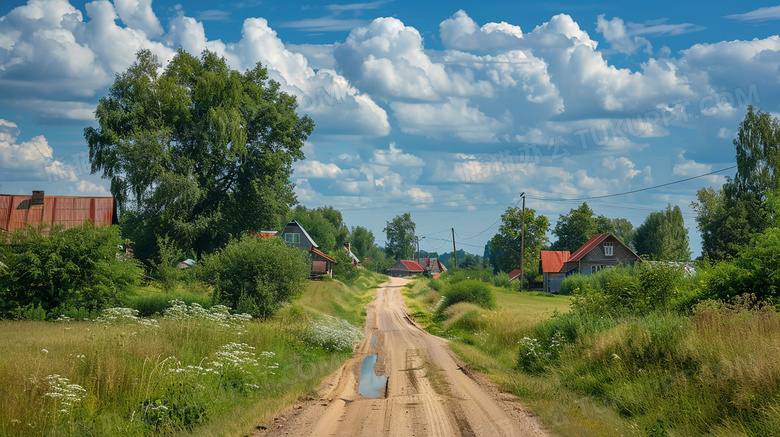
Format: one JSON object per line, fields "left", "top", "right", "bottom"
{"left": 404, "top": 279, "right": 656, "bottom": 436}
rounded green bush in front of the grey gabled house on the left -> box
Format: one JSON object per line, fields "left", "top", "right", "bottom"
{"left": 197, "top": 235, "right": 311, "bottom": 318}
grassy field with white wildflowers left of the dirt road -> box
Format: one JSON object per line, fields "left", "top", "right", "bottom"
{"left": 0, "top": 274, "right": 382, "bottom": 436}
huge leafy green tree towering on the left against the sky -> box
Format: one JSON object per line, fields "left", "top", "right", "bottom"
{"left": 84, "top": 50, "right": 314, "bottom": 258}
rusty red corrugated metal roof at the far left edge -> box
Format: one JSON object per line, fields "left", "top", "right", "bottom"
{"left": 0, "top": 194, "right": 114, "bottom": 232}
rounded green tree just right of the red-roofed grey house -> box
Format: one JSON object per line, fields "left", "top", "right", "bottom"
{"left": 634, "top": 205, "right": 691, "bottom": 261}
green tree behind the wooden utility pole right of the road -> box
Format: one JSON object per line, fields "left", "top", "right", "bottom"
{"left": 490, "top": 206, "right": 550, "bottom": 277}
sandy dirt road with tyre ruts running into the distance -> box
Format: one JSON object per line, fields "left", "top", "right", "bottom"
{"left": 255, "top": 278, "right": 547, "bottom": 437}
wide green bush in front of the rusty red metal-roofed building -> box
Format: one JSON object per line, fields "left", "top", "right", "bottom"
{"left": 0, "top": 222, "right": 143, "bottom": 318}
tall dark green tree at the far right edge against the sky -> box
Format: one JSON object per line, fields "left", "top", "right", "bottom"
{"left": 691, "top": 106, "right": 780, "bottom": 260}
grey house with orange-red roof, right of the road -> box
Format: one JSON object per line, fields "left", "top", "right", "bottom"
{"left": 540, "top": 234, "right": 642, "bottom": 293}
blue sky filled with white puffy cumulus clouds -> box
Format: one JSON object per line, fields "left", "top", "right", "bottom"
{"left": 0, "top": 0, "right": 780, "bottom": 255}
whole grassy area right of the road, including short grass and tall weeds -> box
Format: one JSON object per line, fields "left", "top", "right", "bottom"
{"left": 404, "top": 279, "right": 780, "bottom": 436}
